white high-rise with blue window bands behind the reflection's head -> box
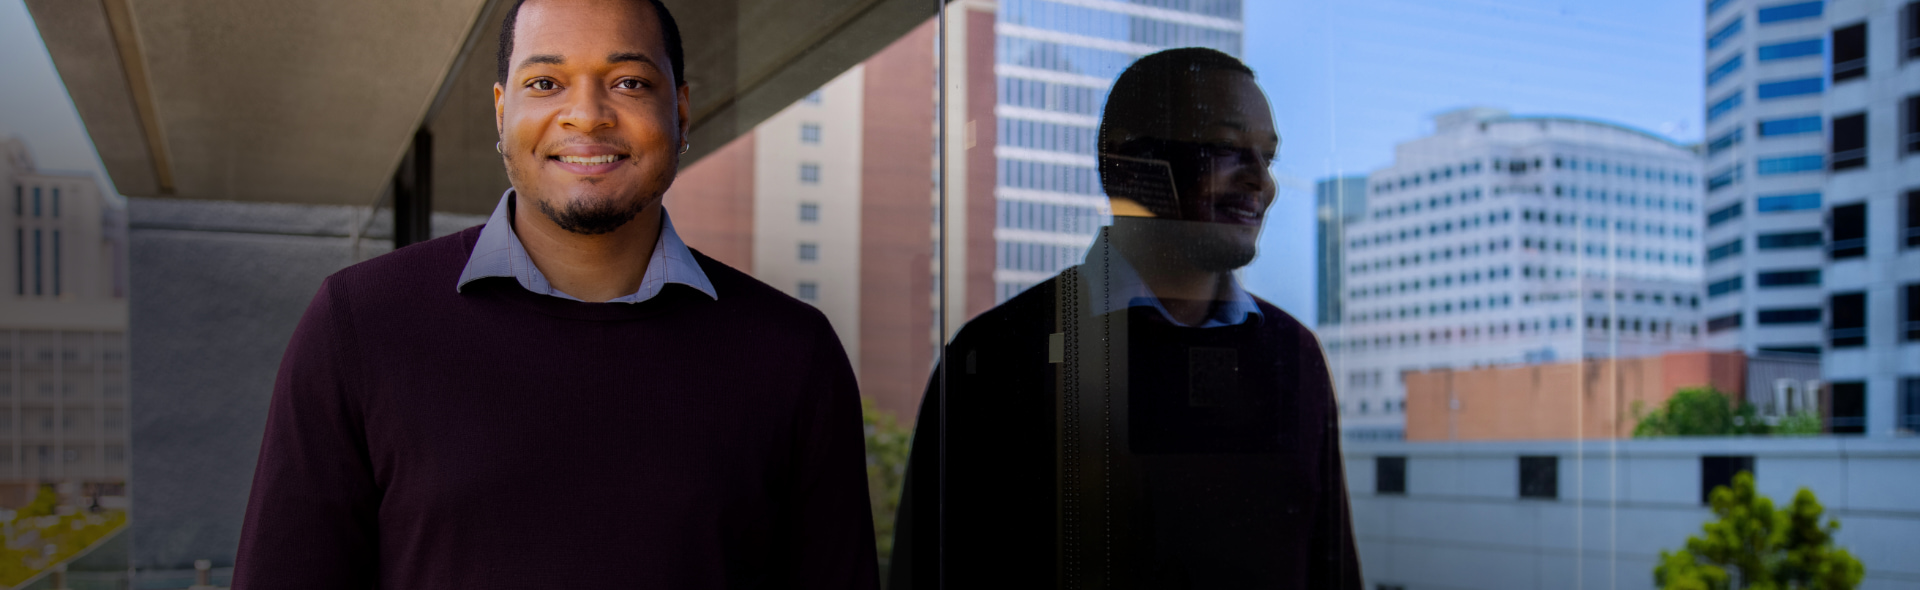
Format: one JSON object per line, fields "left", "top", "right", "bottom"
{"left": 993, "top": 0, "right": 1246, "bottom": 302}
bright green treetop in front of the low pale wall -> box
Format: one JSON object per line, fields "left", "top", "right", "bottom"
{"left": 1653, "top": 471, "right": 1866, "bottom": 590}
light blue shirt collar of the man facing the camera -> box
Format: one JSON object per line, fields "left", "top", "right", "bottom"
{"left": 453, "top": 188, "right": 720, "bottom": 304}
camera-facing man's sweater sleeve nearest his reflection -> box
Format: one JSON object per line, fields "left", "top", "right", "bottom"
{"left": 774, "top": 326, "right": 879, "bottom": 590}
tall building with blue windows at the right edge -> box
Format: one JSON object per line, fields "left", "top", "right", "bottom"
{"left": 1705, "top": 0, "right": 1920, "bottom": 436}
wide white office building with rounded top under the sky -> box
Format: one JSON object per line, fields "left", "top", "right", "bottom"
{"left": 1319, "top": 108, "right": 1703, "bottom": 438}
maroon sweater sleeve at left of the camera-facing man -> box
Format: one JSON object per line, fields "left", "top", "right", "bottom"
{"left": 232, "top": 275, "right": 380, "bottom": 590}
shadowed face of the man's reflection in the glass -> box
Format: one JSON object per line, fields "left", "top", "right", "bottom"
{"left": 1113, "top": 71, "right": 1281, "bottom": 271}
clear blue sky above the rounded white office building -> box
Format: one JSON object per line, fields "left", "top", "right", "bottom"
{"left": 1244, "top": 0, "right": 1703, "bottom": 323}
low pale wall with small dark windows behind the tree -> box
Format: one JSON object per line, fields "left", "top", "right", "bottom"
{"left": 1346, "top": 438, "right": 1920, "bottom": 590}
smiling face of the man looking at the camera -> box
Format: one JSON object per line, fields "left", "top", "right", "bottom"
{"left": 493, "top": 0, "right": 687, "bottom": 234}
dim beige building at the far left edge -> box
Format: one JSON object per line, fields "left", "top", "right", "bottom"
{"left": 0, "top": 138, "right": 127, "bottom": 507}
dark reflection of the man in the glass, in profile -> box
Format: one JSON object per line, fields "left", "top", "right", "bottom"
{"left": 891, "top": 48, "right": 1361, "bottom": 588}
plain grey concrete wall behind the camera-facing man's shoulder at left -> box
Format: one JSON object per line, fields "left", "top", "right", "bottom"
{"left": 129, "top": 198, "right": 486, "bottom": 571}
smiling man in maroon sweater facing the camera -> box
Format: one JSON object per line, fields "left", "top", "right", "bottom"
{"left": 234, "top": 0, "right": 876, "bottom": 590}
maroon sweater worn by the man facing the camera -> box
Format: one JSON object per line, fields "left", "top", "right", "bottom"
{"left": 234, "top": 227, "right": 877, "bottom": 590}
